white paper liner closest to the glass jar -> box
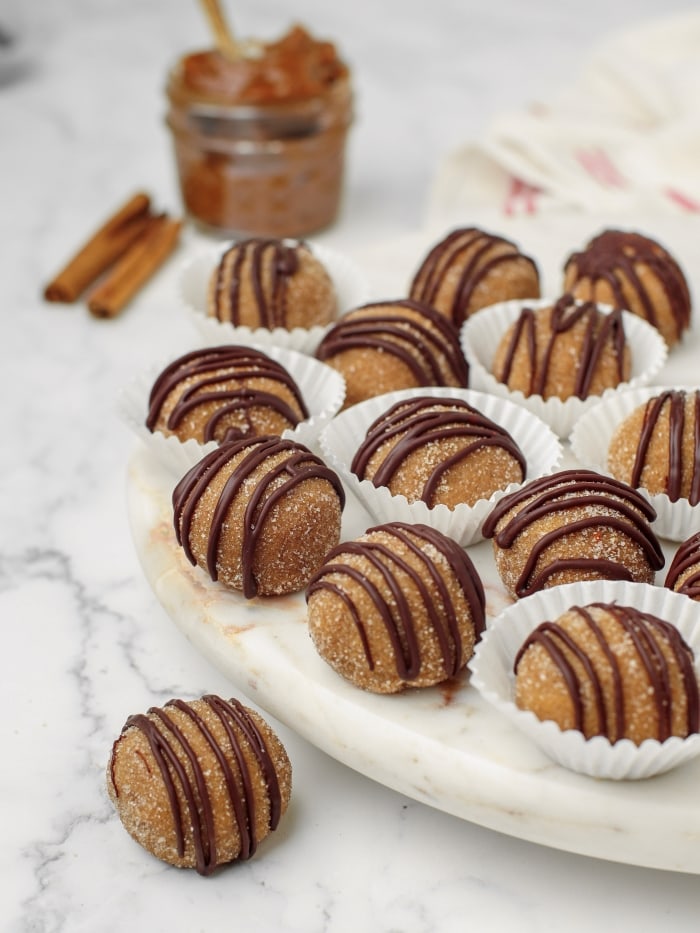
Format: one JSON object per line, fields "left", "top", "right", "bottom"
{"left": 179, "top": 241, "right": 369, "bottom": 354}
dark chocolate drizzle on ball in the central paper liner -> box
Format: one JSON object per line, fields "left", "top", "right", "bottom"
{"left": 350, "top": 396, "right": 527, "bottom": 507}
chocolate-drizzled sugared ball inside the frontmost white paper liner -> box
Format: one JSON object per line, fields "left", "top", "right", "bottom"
{"left": 515, "top": 603, "right": 699, "bottom": 745}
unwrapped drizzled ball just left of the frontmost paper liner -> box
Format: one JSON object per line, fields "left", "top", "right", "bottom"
{"left": 306, "top": 522, "right": 484, "bottom": 693}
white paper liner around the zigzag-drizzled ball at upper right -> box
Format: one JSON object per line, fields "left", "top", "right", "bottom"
{"left": 460, "top": 298, "right": 668, "bottom": 438}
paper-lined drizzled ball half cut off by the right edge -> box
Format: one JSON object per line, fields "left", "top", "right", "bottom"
{"left": 608, "top": 389, "right": 700, "bottom": 505}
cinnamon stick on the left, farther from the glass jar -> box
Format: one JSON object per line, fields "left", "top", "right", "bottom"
{"left": 44, "top": 192, "right": 152, "bottom": 302}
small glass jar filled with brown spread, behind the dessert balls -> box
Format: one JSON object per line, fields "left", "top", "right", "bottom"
{"left": 167, "top": 30, "right": 352, "bottom": 237}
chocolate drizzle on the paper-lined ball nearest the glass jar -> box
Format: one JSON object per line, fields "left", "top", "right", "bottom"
{"left": 214, "top": 238, "right": 302, "bottom": 329}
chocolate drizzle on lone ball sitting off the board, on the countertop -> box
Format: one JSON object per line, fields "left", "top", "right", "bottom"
{"left": 111, "top": 695, "right": 282, "bottom": 875}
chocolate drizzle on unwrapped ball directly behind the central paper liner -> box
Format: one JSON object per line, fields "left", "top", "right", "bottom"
{"left": 316, "top": 299, "right": 469, "bottom": 386}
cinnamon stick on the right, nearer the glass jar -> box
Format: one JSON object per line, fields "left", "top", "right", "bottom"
{"left": 87, "top": 214, "right": 182, "bottom": 318}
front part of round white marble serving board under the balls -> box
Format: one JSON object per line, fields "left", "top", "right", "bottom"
{"left": 128, "top": 447, "right": 700, "bottom": 874}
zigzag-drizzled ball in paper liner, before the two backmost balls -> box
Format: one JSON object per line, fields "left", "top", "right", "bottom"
{"left": 493, "top": 295, "right": 631, "bottom": 401}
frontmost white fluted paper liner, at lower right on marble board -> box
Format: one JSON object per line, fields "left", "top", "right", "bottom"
{"left": 469, "top": 580, "right": 700, "bottom": 780}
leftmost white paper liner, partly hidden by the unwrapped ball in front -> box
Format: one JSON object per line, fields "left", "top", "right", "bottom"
{"left": 118, "top": 343, "right": 345, "bottom": 476}
